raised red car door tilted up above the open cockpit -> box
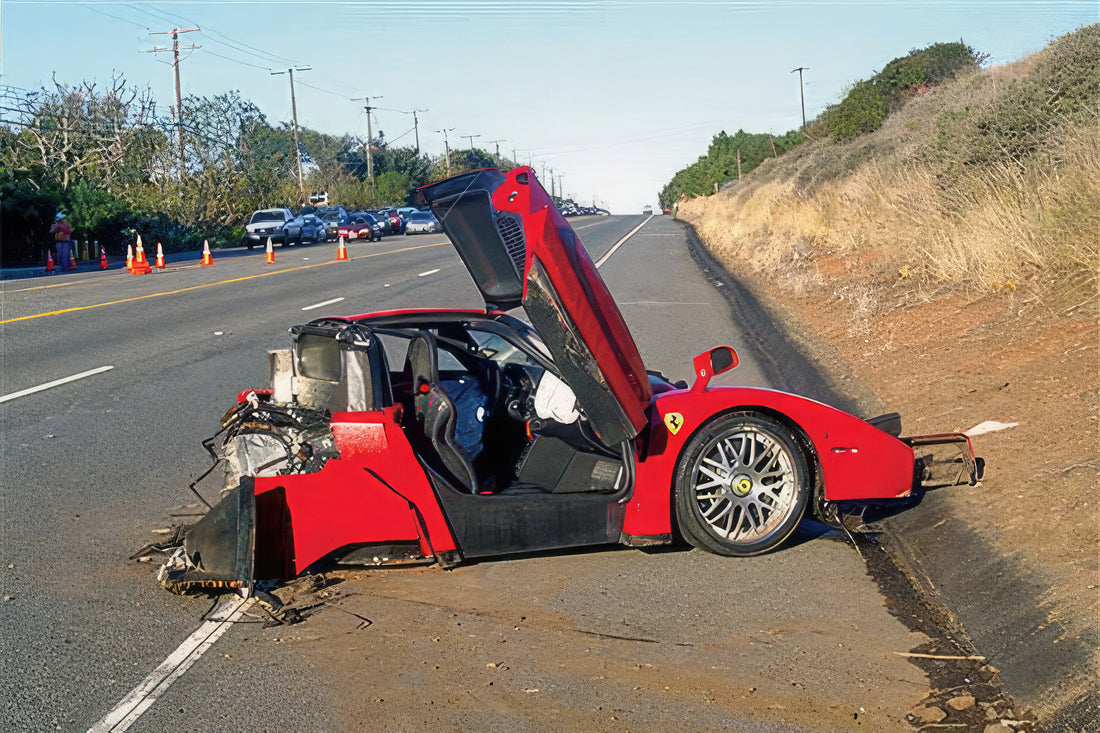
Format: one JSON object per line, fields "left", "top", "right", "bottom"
{"left": 419, "top": 167, "right": 650, "bottom": 447}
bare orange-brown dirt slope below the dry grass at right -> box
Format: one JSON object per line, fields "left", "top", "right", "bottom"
{"left": 677, "top": 214, "right": 1100, "bottom": 730}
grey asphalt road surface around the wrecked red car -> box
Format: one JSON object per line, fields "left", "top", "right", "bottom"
{"left": 0, "top": 217, "right": 927, "bottom": 731}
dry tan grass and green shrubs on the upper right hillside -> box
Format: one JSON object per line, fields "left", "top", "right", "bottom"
{"left": 681, "top": 25, "right": 1100, "bottom": 294}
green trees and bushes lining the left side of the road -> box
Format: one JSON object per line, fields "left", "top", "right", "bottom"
{"left": 0, "top": 77, "right": 499, "bottom": 265}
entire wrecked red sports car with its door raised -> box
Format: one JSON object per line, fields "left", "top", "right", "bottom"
{"left": 160, "top": 167, "right": 982, "bottom": 592}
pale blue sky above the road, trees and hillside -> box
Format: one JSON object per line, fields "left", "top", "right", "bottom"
{"left": 0, "top": 0, "right": 1100, "bottom": 212}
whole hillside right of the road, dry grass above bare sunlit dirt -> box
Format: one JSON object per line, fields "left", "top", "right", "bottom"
{"left": 680, "top": 25, "right": 1100, "bottom": 713}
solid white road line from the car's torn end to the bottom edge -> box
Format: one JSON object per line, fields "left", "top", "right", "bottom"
{"left": 88, "top": 598, "right": 255, "bottom": 733}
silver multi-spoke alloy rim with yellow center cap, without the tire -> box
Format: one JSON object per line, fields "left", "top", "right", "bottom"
{"left": 691, "top": 425, "right": 799, "bottom": 544}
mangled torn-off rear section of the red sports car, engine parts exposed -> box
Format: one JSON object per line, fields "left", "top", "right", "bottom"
{"left": 158, "top": 321, "right": 454, "bottom": 593}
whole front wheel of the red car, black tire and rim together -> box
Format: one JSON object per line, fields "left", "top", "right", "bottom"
{"left": 674, "top": 413, "right": 811, "bottom": 557}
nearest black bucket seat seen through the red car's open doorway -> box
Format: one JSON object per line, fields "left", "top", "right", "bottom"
{"left": 405, "top": 331, "right": 479, "bottom": 493}
